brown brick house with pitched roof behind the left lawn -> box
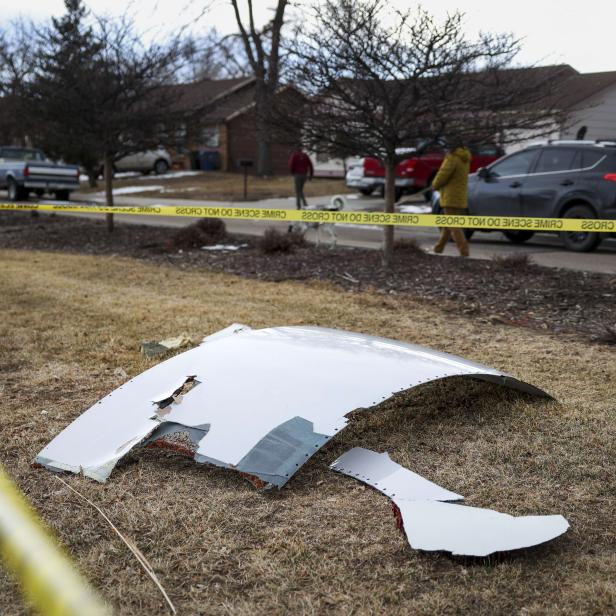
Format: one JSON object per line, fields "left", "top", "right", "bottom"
{"left": 162, "top": 77, "right": 297, "bottom": 174}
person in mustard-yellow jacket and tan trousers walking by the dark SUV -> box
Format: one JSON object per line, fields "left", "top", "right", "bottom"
{"left": 432, "top": 146, "right": 471, "bottom": 257}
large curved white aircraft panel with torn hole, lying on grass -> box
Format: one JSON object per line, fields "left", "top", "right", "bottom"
{"left": 36, "top": 324, "right": 549, "bottom": 487}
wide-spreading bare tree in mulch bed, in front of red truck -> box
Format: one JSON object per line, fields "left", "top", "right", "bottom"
{"left": 290, "top": 0, "right": 564, "bottom": 267}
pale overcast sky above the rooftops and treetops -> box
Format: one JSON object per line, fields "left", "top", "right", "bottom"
{"left": 0, "top": 0, "right": 616, "bottom": 73}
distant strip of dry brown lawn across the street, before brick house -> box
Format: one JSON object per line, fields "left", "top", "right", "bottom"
{"left": 80, "top": 171, "right": 355, "bottom": 201}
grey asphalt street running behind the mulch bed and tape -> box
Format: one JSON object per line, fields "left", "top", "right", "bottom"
{"left": 36, "top": 193, "right": 616, "bottom": 274}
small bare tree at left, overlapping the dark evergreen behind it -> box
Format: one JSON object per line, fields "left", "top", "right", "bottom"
{"left": 28, "top": 0, "right": 181, "bottom": 231}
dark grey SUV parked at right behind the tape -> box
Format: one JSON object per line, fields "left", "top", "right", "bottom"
{"left": 435, "top": 140, "right": 616, "bottom": 252}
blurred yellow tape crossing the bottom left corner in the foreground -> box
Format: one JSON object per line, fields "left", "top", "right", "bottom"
{"left": 0, "top": 468, "right": 111, "bottom": 616}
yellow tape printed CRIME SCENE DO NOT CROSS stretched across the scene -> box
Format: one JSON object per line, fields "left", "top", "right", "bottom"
{"left": 0, "top": 203, "right": 616, "bottom": 233}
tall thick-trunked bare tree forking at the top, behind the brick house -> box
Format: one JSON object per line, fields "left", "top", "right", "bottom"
{"left": 230, "top": 0, "right": 289, "bottom": 175}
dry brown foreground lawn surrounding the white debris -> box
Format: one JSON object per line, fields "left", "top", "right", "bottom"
{"left": 0, "top": 251, "right": 616, "bottom": 616}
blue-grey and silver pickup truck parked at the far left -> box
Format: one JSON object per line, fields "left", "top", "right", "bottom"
{"left": 0, "top": 146, "right": 79, "bottom": 201}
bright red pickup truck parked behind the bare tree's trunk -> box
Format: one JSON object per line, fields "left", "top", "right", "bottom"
{"left": 346, "top": 142, "right": 504, "bottom": 201}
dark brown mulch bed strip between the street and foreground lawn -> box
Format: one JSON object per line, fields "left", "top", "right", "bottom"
{"left": 0, "top": 212, "right": 616, "bottom": 343}
